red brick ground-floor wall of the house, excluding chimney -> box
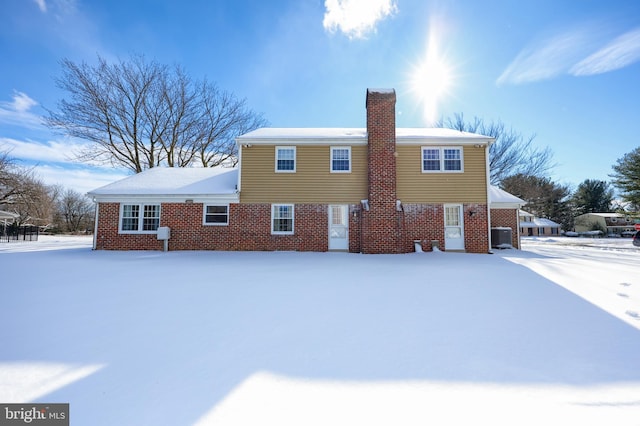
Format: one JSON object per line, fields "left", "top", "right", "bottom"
{"left": 96, "top": 203, "right": 492, "bottom": 253}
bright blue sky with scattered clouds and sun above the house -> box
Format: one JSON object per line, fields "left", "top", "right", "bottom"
{"left": 0, "top": 0, "right": 640, "bottom": 192}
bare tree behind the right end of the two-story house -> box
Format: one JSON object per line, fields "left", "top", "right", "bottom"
{"left": 438, "top": 114, "right": 554, "bottom": 185}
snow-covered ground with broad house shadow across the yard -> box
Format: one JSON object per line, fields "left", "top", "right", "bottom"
{"left": 0, "top": 236, "right": 640, "bottom": 426}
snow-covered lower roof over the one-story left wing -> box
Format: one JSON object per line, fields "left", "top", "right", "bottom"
{"left": 88, "top": 167, "right": 238, "bottom": 201}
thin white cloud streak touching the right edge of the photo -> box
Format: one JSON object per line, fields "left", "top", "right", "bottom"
{"left": 569, "top": 28, "right": 640, "bottom": 76}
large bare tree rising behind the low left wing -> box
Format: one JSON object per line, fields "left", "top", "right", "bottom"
{"left": 45, "top": 56, "right": 268, "bottom": 173}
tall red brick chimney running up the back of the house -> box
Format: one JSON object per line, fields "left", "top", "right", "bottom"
{"left": 362, "top": 89, "right": 402, "bottom": 253}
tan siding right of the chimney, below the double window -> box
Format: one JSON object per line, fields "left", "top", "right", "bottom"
{"left": 397, "top": 145, "right": 487, "bottom": 203}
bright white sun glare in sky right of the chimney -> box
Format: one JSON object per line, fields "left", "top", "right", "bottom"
{"left": 410, "top": 27, "right": 453, "bottom": 124}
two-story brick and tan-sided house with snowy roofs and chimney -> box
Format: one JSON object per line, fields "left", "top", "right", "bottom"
{"left": 89, "top": 89, "right": 520, "bottom": 253}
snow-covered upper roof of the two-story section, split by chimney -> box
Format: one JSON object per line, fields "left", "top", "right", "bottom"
{"left": 236, "top": 127, "right": 494, "bottom": 145}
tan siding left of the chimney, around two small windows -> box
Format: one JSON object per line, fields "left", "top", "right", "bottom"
{"left": 240, "top": 145, "right": 367, "bottom": 203}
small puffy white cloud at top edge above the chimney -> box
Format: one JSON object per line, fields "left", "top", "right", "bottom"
{"left": 322, "top": 0, "right": 398, "bottom": 38}
